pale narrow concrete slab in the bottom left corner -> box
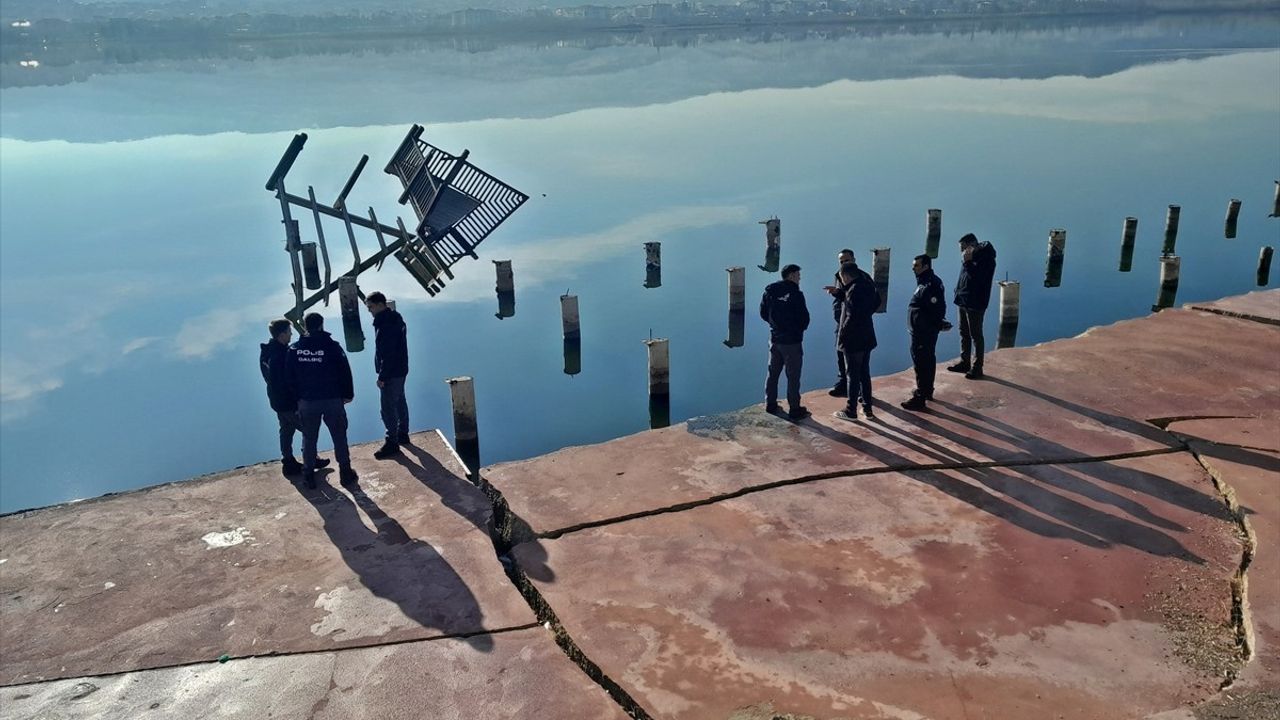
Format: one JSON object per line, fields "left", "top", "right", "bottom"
{"left": 0, "top": 628, "right": 626, "bottom": 720}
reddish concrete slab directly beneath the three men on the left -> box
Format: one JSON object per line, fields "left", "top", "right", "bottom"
{"left": 0, "top": 432, "right": 535, "bottom": 684}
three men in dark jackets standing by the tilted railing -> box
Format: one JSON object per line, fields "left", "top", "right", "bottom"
{"left": 259, "top": 292, "right": 410, "bottom": 489}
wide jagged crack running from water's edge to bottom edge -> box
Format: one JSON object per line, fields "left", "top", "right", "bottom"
{"left": 470, "top": 471, "right": 653, "bottom": 720}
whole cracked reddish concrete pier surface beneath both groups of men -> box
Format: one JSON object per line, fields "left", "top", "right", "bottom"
{"left": 0, "top": 291, "right": 1280, "bottom": 720}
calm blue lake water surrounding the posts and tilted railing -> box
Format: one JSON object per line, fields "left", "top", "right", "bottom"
{"left": 0, "top": 14, "right": 1280, "bottom": 511}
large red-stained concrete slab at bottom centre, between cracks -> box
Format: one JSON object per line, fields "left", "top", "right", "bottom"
{"left": 516, "top": 452, "right": 1240, "bottom": 720}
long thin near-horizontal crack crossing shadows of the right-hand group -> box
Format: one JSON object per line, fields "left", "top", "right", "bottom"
{"left": 535, "top": 442, "right": 1188, "bottom": 544}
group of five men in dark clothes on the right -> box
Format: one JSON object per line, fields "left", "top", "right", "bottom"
{"left": 760, "top": 233, "right": 996, "bottom": 420}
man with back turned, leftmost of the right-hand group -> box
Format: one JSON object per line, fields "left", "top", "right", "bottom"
{"left": 760, "top": 265, "right": 809, "bottom": 420}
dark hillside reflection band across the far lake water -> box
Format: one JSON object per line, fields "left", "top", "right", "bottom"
{"left": 0, "top": 13, "right": 1280, "bottom": 140}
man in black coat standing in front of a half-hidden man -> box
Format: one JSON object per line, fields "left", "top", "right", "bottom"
{"left": 836, "top": 254, "right": 879, "bottom": 420}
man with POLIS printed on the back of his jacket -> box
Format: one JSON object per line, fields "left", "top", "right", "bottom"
{"left": 288, "top": 313, "right": 360, "bottom": 489}
